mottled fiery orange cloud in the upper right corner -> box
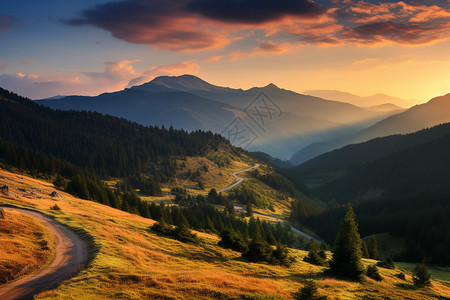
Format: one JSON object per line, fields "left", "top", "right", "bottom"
{"left": 334, "top": 0, "right": 450, "bottom": 45}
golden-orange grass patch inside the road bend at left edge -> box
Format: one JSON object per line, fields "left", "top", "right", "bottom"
{"left": 0, "top": 211, "right": 56, "bottom": 284}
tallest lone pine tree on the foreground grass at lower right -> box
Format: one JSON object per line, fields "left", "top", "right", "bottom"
{"left": 330, "top": 203, "right": 364, "bottom": 280}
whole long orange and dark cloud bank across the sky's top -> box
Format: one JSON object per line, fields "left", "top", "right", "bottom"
{"left": 64, "top": 0, "right": 450, "bottom": 50}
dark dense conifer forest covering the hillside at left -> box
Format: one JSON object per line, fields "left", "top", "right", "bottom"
{"left": 0, "top": 88, "right": 228, "bottom": 182}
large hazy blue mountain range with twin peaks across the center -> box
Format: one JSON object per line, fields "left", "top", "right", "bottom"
{"left": 37, "top": 75, "right": 400, "bottom": 159}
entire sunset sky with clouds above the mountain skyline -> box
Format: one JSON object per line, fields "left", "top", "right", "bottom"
{"left": 0, "top": 0, "right": 450, "bottom": 103}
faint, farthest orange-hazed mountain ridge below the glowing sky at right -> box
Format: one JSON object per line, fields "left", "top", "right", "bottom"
{"left": 303, "top": 90, "right": 415, "bottom": 108}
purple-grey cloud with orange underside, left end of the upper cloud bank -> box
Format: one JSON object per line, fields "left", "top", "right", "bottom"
{"left": 64, "top": 0, "right": 229, "bottom": 51}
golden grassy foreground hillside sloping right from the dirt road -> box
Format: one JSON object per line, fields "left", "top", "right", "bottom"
{"left": 0, "top": 171, "right": 450, "bottom": 300}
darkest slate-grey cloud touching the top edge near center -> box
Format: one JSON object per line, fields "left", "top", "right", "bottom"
{"left": 186, "top": 0, "right": 325, "bottom": 24}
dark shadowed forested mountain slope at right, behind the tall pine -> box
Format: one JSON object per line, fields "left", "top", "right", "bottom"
{"left": 285, "top": 124, "right": 450, "bottom": 265}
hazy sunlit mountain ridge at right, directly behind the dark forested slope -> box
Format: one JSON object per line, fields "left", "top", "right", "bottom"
{"left": 290, "top": 94, "right": 450, "bottom": 165}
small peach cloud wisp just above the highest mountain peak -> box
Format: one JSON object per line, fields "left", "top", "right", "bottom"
{"left": 127, "top": 60, "right": 200, "bottom": 87}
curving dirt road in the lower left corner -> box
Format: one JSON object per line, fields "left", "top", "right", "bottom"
{"left": 0, "top": 207, "right": 88, "bottom": 300}
